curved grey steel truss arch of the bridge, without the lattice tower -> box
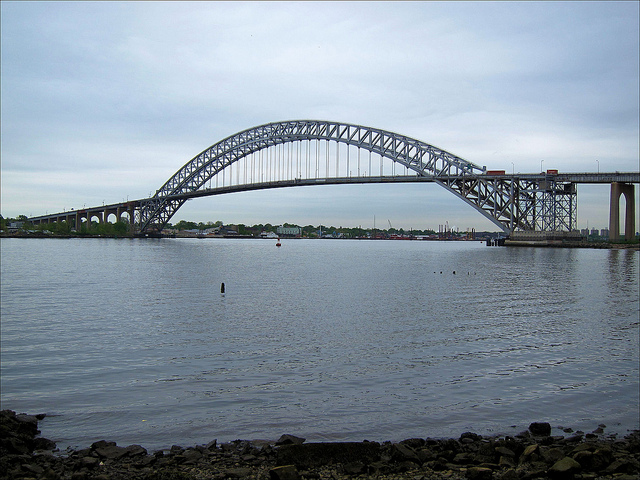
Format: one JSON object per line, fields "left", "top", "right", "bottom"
{"left": 140, "top": 120, "right": 484, "bottom": 233}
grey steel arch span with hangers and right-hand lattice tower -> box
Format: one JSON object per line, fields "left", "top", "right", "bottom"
{"left": 139, "top": 120, "right": 576, "bottom": 233}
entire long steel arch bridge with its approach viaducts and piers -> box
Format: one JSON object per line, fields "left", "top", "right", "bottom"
{"left": 29, "top": 120, "right": 640, "bottom": 239}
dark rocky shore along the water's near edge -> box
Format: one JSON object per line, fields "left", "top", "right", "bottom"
{"left": 0, "top": 410, "right": 640, "bottom": 480}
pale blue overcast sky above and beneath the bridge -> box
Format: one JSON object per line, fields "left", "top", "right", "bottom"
{"left": 0, "top": 0, "right": 640, "bottom": 231}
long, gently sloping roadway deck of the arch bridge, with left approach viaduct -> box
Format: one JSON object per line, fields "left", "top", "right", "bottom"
{"left": 28, "top": 172, "right": 640, "bottom": 230}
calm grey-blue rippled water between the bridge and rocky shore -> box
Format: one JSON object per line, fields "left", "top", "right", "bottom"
{"left": 0, "top": 239, "right": 640, "bottom": 450}
